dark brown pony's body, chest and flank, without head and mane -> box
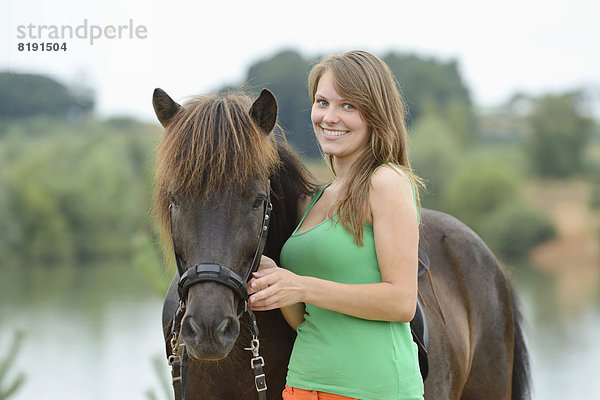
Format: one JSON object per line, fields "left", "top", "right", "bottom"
{"left": 163, "top": 209, "right": 526, "bottom": 400}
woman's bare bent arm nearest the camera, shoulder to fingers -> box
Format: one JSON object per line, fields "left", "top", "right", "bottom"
{"left": 250, "top": 167, "right": 419, "bottom": 322}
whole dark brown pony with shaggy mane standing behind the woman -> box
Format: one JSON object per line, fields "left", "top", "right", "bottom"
{"left": 153, "top": 89, "right": 529, "bottom": 400}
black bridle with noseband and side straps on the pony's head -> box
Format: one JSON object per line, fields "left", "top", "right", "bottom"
{"left": 167, "top": 181, "right": 273, "bottom": 400}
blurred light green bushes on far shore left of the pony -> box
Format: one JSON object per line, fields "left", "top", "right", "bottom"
{"left": 0, "top": 120, "right": 158, "bottom": 264}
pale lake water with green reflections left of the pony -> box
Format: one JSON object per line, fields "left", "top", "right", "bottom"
{"left": 0, "top": 265, "right": 168, "bottom": 400}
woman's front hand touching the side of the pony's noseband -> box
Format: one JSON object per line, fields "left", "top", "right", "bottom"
{"left": 248, "top": 256, "right": 304, "bottom": 311}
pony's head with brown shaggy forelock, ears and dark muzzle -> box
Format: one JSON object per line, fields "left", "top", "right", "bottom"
{"left": 153, "top": 89, "right": 279, "bottom": 360}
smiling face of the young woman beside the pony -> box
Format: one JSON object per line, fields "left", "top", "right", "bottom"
{"left": 310, "top": 71, "right": 371, "bottom": 161}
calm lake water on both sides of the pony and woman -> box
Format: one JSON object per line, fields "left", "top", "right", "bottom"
{"left": 0, "top": 265, "right": 600, "bottom": 400}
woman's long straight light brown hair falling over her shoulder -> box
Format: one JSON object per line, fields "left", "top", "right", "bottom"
{"left": 308, "top": 50, "right": 423, "bottom": 246}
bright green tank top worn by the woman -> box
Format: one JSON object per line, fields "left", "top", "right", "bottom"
{"left": 281, "top": 167, "right": 423, "bottom": 400}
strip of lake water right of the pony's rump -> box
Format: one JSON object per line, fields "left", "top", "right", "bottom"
{"left": 513, "top": 267, "right": 600, "bottom": 400}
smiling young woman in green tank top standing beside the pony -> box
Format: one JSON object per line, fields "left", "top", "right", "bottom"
{"left": 250, "top": 51, "right": 423, "bottom": 400}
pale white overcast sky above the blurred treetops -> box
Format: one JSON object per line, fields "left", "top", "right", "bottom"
{"left": 0, "top": 0, "right": 600, "bottom": 119}
